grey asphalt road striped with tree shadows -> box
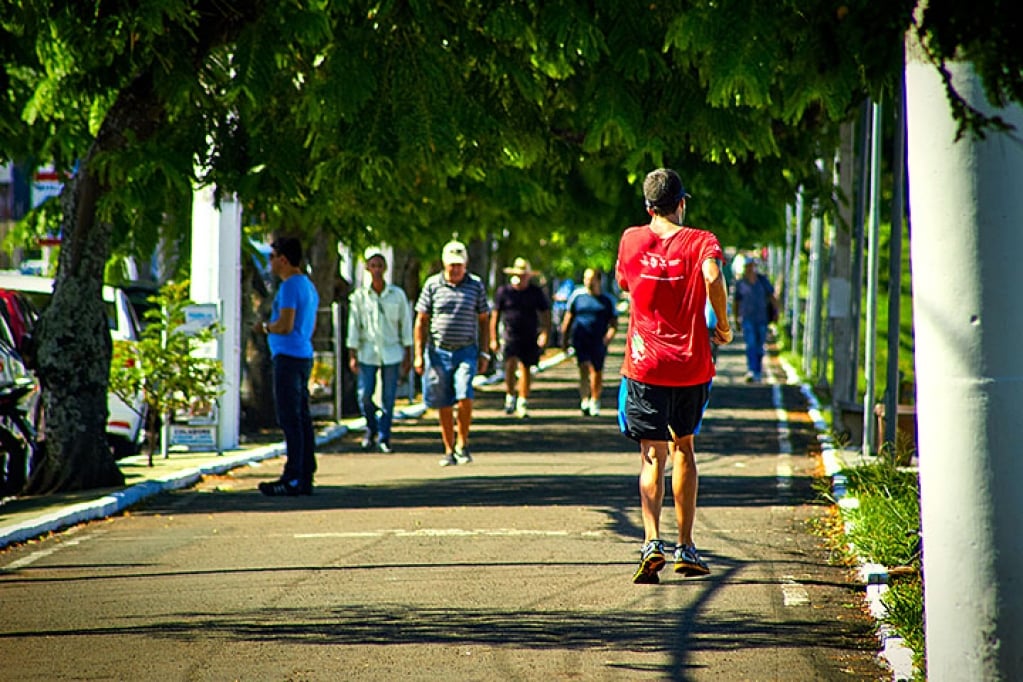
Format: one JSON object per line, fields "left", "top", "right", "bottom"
{"left": 0, "top": 347, "right": 890, "bottom": 682}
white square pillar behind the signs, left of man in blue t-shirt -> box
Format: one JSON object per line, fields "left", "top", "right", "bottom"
{"left": 190, "top": 187, "right": 242, "bottom": 452}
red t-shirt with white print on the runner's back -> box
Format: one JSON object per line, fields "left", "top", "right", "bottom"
{"left": 615, "top": 225, "right": 722, "bottom": 387}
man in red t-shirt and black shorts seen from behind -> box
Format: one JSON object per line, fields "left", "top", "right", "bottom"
{"left": 616, "top": 169, "right": 732, "bottom": 584}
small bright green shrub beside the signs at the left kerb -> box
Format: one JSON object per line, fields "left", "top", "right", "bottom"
{"left": 110, "top": 280, "right": 223, "bottom": 456}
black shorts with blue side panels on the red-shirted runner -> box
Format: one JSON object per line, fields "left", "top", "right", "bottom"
{"left": 618, "top": 376, "right": 711, "bottom": 441}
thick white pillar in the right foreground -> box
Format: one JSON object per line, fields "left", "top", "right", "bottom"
{"left": 905, "top": 54, "right": 1023, "bottom": 682}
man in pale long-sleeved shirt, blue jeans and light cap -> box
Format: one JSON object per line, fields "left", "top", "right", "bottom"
{"left": 346, "top": 246, "right": 412, "bottom": 453}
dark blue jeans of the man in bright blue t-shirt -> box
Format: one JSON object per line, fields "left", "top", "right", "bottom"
{"left": 273, "top": 355, "right": 316, "bottom": 485}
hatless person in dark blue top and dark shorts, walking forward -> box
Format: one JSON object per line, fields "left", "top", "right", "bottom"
{"left": 562, "top": 268, "right": 618, "bottom": 417}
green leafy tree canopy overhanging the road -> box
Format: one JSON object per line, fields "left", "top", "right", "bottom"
{"left": 0, "top": 0, "right": 1021, "bottom": 486}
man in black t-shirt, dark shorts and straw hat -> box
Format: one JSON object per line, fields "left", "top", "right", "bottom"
{"left": 490, "top": 258, "right": 550, "bottom": 418}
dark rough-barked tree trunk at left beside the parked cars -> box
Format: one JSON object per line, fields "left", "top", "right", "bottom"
{"left": 26, "top": 79, "right": 163, "bottom": 494}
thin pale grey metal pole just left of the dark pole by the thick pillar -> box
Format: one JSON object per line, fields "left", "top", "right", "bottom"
{"left": 862, "top": 97, "right": 881, "bottom": 456}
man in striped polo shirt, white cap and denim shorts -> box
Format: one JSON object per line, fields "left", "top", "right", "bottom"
{"left": 412, "top": 241, "right": 490, "bottom": 466}
